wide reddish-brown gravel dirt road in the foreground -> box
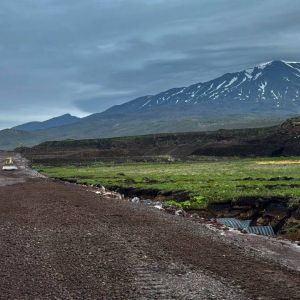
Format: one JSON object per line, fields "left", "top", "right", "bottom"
{"left": 0, "top": 153, "right": 300, "bottom": 300}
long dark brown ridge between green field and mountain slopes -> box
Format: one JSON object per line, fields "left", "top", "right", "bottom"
{"left": 19, "top": 118, "right": 300, "bottom": 163}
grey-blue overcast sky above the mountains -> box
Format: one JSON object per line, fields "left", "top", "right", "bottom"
{"left": 0, "top": 0, "right": 300, "bottom": 128}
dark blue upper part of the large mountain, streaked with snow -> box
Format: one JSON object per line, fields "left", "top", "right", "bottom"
{"left": 105, "top": 61, "right": 300, "bottom": 112}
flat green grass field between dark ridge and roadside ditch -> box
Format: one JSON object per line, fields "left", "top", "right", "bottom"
{"left": 35, "top": 158, "right": 300, "bottom": 208}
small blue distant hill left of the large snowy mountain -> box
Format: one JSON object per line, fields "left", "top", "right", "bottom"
{"left": 13, "top": 114, "right": 80, "bottom": 132}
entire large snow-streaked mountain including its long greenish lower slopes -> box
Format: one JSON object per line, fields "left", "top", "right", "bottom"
{"left": 0, "top": 61, "right": 300, "bottom": 149}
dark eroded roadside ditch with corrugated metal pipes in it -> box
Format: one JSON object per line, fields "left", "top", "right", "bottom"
{"left": 111, "top": 187, "right": 300, "bottom": 240}
